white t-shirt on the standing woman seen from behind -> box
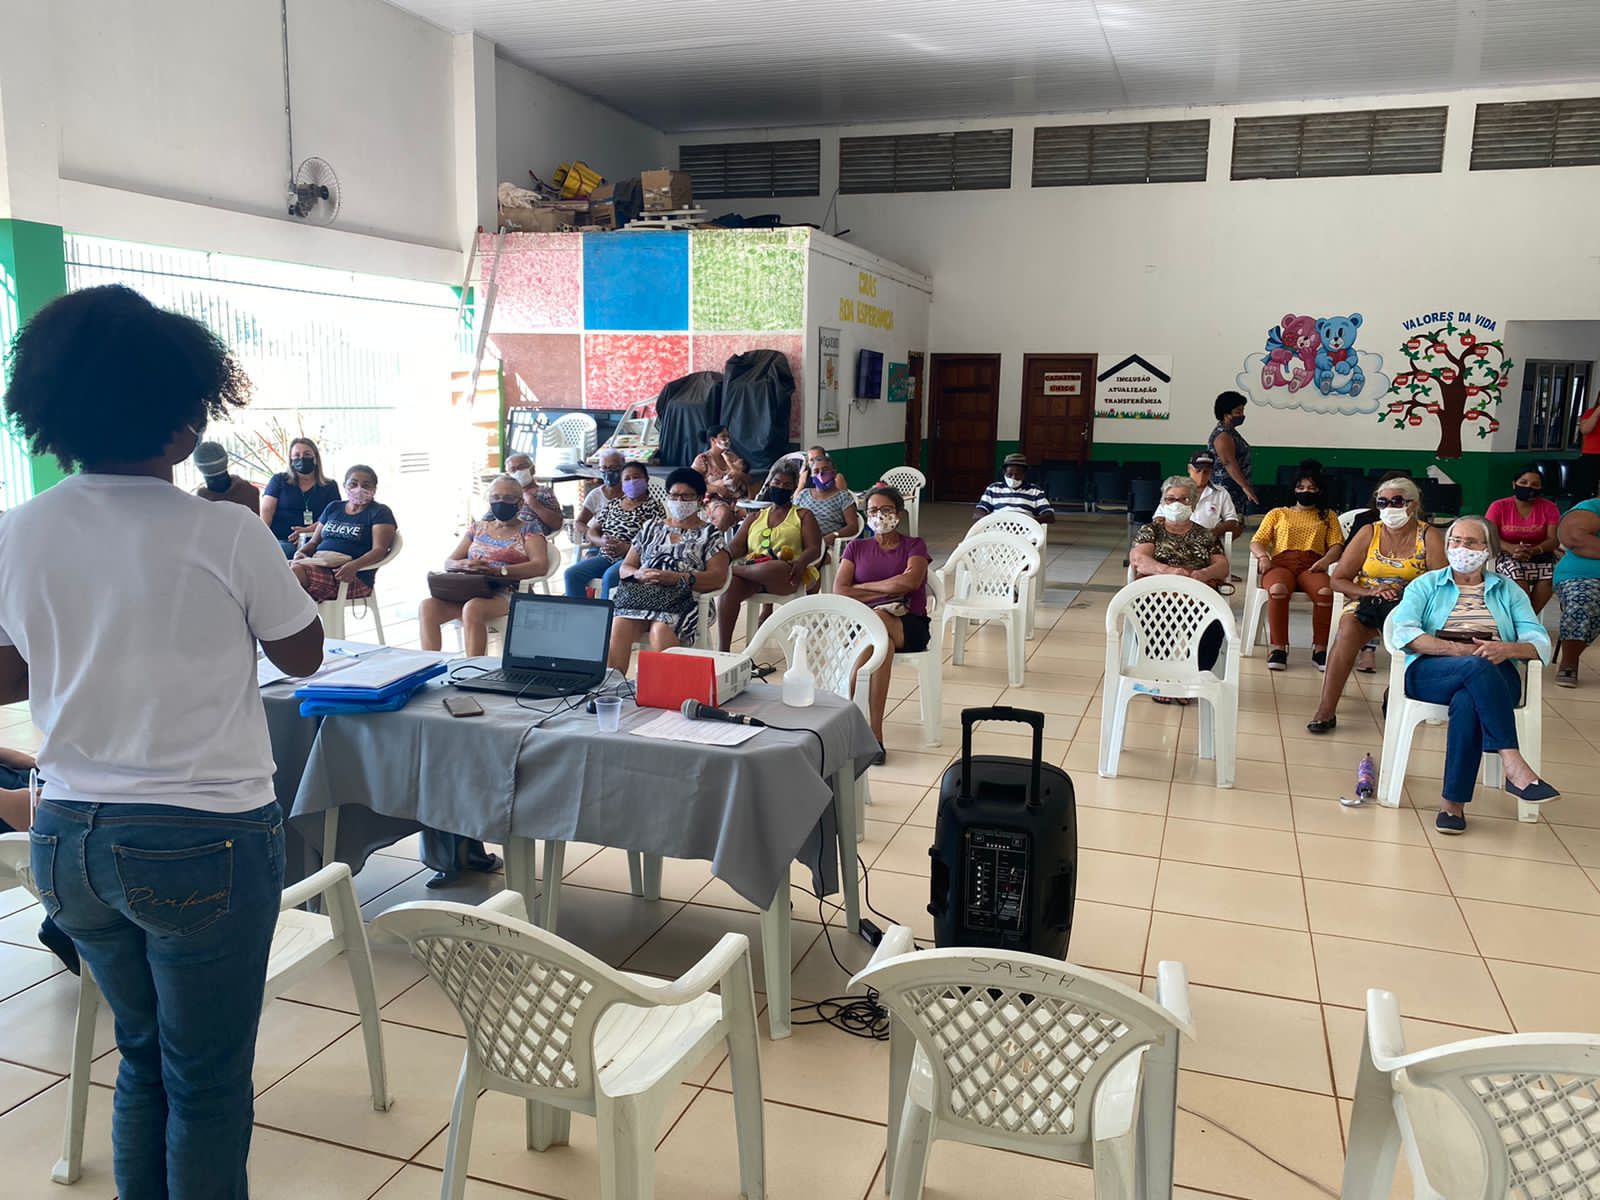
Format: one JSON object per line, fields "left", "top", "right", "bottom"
{"left": 0, "top": 475, "right": 317, "bottom": 813}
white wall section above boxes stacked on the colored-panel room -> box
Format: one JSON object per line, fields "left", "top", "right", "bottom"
{"left": 494, "top": 55, "right": 659, "bottom": 187}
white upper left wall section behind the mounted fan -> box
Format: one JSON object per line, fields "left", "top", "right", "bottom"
{"left": 51, "top": 0, "right": 459, "bottom": 248}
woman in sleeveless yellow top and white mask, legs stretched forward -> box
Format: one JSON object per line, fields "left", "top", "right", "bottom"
{"left": 1306, "top": 478, "right": 1445, "bottom": 733}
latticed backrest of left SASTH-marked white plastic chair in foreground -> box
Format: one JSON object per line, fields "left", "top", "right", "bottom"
{"left": 373, "top": 901, "right": 658, "bottom": 1101}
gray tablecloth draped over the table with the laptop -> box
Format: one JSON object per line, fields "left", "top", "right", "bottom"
{"left": 262, "top": 683, "right": 878, "bottom": 907}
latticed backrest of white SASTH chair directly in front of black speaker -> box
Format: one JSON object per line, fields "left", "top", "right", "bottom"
{"left": 854, "top": 947, "right": 1184, "bottom": 1147}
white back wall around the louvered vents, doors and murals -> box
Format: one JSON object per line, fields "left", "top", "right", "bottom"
{"left": 672, "top": 85, "right": 1600, "bottom": 450}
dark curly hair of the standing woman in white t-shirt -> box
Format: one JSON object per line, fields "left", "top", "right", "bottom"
{"left": 5, "top": 286, "right": 250, "bottom": 470}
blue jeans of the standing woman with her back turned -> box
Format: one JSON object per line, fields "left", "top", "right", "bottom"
{"left": 30, "top": 800, "right": 283, "bottom": 1200}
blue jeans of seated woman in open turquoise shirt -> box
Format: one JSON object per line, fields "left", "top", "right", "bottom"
{"left": 1405, "top": 654, "right": 1522, "bottom": 805}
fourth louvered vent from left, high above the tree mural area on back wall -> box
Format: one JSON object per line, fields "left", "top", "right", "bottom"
{"left": 1230, "top": 107, "right": 1446, "bottom": 179}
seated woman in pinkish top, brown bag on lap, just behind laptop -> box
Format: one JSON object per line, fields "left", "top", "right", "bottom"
{"left": 416, "top": 475, "right": 550, "bottom": 658}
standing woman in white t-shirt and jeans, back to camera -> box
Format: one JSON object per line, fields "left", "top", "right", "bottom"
{"left": 0, "top": 286, "right": 322, "bottom": 1200}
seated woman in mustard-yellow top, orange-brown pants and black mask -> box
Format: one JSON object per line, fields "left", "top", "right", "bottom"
{"left": 1250, "top": 462, "right": 1344, "bottom": 670}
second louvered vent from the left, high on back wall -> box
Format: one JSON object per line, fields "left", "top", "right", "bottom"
{"left": 838, "top": 130, "right": 1011, "bottom": 195}
